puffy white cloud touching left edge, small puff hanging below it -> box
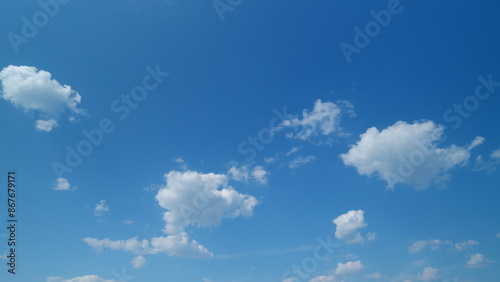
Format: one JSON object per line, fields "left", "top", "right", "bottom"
{"left": 0, "top": 65, "right": 83, "bottom": 131}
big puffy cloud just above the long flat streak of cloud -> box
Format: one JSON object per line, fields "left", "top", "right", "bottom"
{"left": 156, "top": 171, "right": 258, "bottom": 234}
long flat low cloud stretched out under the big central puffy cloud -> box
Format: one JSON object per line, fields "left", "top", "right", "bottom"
{"left": 83, "top": 232, "right": 214, "bottom": 259}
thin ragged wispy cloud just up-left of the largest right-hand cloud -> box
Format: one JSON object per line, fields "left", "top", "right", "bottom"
{"left": 278, "top": 99, "right": 354, "bottom": 140}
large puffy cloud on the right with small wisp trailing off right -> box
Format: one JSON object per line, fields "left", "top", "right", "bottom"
{"left": 340, "top": 121, "right": 484, "bottom": 189}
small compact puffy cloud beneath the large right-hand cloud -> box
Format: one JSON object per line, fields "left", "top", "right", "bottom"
{"left": 333, "top": 210, "right": 376, "bottom": 244}
